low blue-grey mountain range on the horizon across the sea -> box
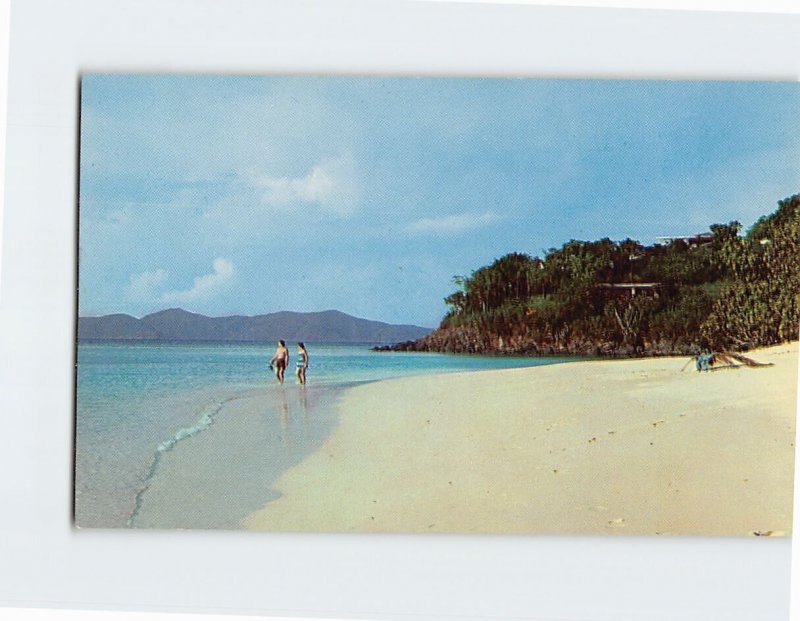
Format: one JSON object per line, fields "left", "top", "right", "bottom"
{"left": 78, "top": 308, "right": 431, "bottom": 343}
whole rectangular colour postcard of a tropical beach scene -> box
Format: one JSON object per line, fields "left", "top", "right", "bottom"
{"left": 74, "top": 73, "right": 800, "bottom": 537}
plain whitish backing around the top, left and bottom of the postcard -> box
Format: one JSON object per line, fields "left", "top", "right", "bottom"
{"left": 0, "top": 0, "right": 800, "bottom": 621}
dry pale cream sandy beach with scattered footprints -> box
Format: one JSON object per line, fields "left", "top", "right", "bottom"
{"left": 244, "top": 343, "right": 798, "bottom": 536}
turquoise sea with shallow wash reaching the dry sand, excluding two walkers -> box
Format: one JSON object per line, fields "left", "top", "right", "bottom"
{"left": 75, "top": 342, "right": 567, "bottom": 528}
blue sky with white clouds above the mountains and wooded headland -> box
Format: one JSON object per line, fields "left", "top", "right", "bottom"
{"left": 79, "top": 74, "right": 800, "bottom": 326}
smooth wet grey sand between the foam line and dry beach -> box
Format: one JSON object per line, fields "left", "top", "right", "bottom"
{"left": 128, "top": 385, "right": 341, "bottom": 529}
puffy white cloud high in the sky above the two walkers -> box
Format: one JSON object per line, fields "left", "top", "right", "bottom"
{"left": 243, "top": 156, "right": 358, "bottom": 217}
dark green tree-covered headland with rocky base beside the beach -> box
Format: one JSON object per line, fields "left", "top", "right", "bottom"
{"left": 413, "top": 195, "right": 800, "bottom": 355}
